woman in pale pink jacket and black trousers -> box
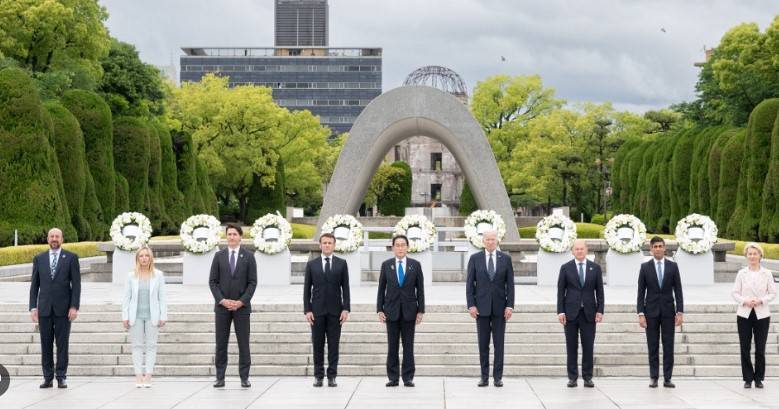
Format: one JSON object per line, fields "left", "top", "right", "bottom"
{"left": 733, "top": 243, "right": 776, "bottom": 388}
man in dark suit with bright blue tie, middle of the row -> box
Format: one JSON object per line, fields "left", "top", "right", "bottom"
{"left": 376, "top": 235, "right": 425, "bottom": 387}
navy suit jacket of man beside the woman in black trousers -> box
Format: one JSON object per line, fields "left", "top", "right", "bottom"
{"left": 636, "top": 258, "right": 684, "bottom": 318}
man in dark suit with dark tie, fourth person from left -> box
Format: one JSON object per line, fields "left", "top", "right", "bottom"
{"left": 303, "top": 233, "right": 350, "bottom": 387}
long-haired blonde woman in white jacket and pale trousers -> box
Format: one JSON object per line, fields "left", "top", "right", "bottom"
{"left": 122, "top": 245, "right": 168, "bottom": 388}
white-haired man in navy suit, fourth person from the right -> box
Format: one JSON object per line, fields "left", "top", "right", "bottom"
{"left": 465, "top": 231, "right": 514, "bottom": 387}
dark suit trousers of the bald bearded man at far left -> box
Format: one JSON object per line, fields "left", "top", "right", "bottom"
{"left": 38, "top": 314, "right": 70, "bottom": 380}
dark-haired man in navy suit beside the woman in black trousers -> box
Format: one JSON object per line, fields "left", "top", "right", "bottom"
{"left": 636, "top": 236, "right": 684, "bottom": 388}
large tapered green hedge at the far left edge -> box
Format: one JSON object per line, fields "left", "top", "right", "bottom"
{"left": 0, "top": 68, "right": 76, "bottom": 245}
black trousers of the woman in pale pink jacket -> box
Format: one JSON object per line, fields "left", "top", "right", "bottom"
{"left": 737, "top": 310, "right": 771, "bottom": 382}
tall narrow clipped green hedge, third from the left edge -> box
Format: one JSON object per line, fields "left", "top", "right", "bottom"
{"left": 61, "top": 89, "right": 118, "bottom": 217}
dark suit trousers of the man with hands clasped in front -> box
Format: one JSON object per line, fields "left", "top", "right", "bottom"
{"left": 214, "top": 311, "right": 252, "bottom": 379}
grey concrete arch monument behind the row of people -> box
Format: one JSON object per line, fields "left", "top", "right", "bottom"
{"left": 317, "top": 86, "right": 519, "bottom": 241}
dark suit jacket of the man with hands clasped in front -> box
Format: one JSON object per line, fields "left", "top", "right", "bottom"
{"left": 208, "top": 247, "right": 257, "bottom": 314}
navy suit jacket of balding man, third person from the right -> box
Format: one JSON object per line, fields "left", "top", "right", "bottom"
{"left": 557, "top": 259, "right": 604, "bottom": 322}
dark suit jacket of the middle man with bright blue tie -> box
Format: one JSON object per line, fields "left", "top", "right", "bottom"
{"left": 376, "top": 257, "right": 425, "bottom": 321}
